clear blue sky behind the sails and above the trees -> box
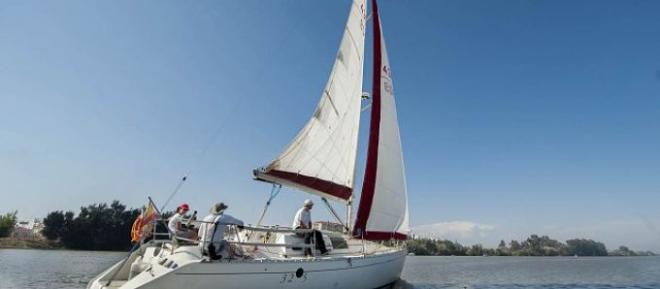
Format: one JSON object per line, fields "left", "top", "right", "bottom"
{"left": 0, "top": 0, "right": 660, "bottom": 251}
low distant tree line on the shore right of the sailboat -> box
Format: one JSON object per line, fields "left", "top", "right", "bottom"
{"left": 408, "top": 235, "right": 655, "bottom": 256}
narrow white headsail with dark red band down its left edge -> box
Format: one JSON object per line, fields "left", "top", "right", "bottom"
{"left": 353, "top": 0, "right": 409, "bottom": 240}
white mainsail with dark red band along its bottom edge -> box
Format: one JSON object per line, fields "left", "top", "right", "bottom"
{"left": 255, "top": 0, "right": 367, "bottom": 201}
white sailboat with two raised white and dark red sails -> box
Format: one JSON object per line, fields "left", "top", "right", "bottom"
{"left": 87, "top": 0, "right": 409, "bottom": 289}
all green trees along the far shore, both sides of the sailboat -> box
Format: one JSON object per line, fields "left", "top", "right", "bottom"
{"left": 0, "top": 201, "right": 654, "bottom": 256}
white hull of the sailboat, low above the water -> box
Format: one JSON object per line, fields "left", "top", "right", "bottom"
{"left": 88, "top": 245, "right": 406, "bottom": 289}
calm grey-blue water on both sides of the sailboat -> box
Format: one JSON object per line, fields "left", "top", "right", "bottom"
{"left": 0, "top": 250, "right": 660, "bottom": 289}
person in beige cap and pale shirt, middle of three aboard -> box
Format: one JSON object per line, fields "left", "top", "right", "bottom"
{"left": 199, "top": 203, "right": 243, "bottom": 257}
